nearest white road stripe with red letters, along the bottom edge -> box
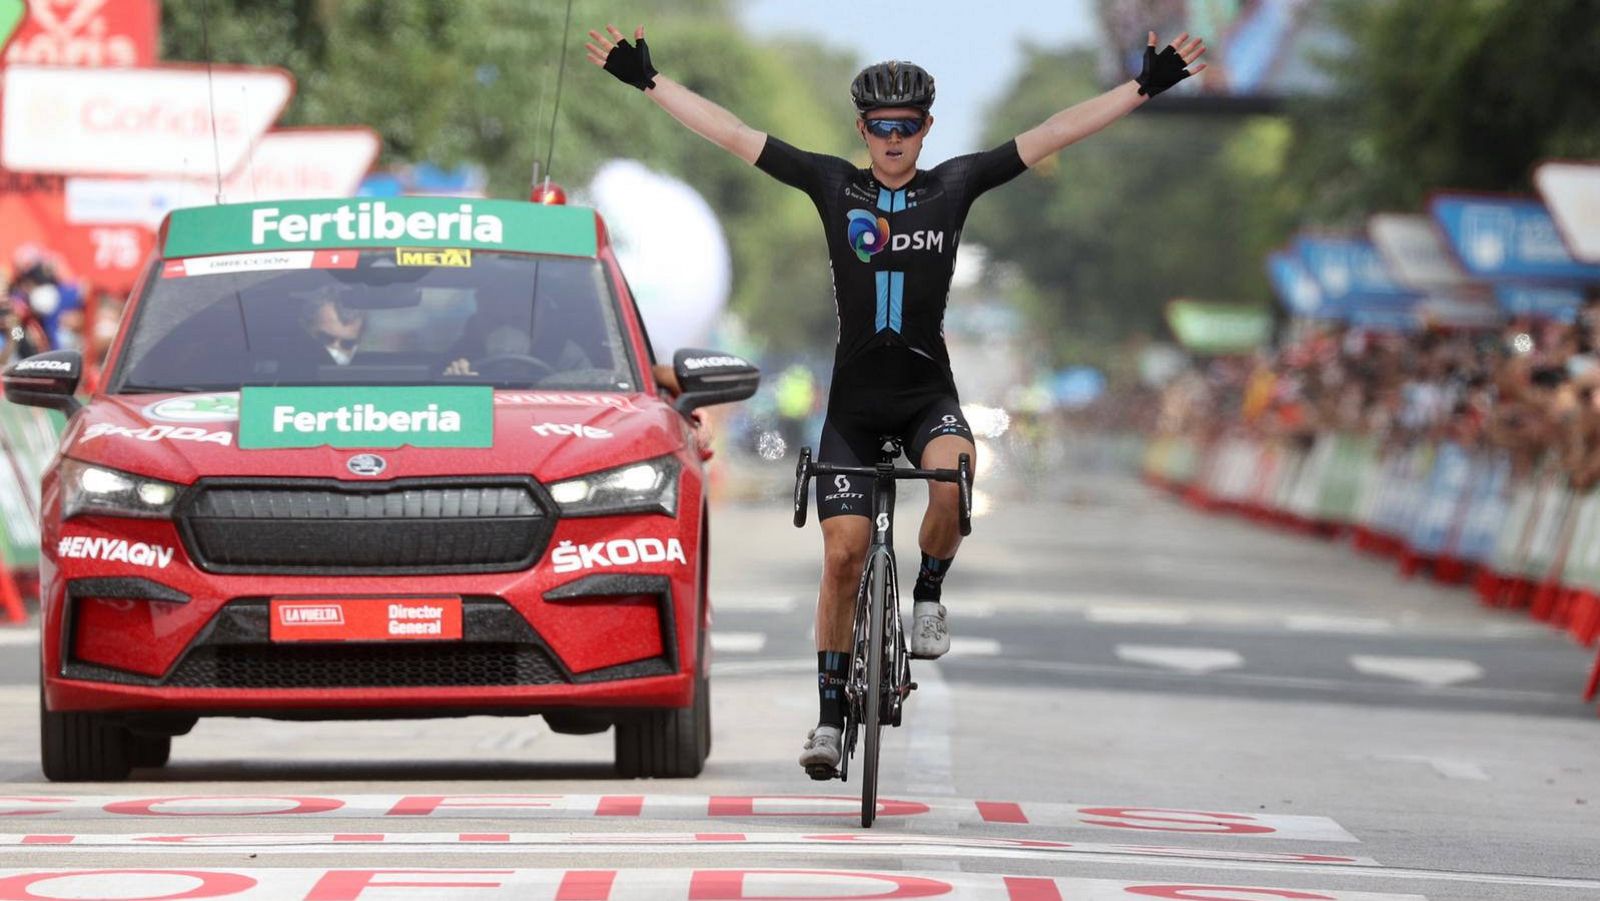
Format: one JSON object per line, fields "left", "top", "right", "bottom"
{"left": 0, "top": 867, "right": 1426, "bottom": 901}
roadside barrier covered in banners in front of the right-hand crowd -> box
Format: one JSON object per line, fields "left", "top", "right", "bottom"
{"left": 1144, "top": 434, "right": 1600, "bottom": 716}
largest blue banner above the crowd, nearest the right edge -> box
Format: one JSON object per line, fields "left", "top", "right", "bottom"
{"left": 1429, "top": 194, "right": 1600, "bottom": 282}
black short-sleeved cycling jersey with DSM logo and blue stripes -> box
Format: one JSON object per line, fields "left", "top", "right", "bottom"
{"left": 755, "top": 136, "right": 1027, "bottom": 381}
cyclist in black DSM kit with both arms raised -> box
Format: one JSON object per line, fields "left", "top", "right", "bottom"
{"left": 586, "top": 26, "right": 1205, "bottom": 778}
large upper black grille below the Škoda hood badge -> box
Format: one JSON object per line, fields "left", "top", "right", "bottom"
{"left": 178, "top": 480, "right": 554, "bottom": 575}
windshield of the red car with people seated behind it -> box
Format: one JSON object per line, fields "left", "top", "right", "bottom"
{"left": 110, "top": 248, "right": 637, "bottom": 392}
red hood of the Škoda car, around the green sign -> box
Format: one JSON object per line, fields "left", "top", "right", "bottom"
{"left": 61, "top": 389, "right": 686, "bottom": 483}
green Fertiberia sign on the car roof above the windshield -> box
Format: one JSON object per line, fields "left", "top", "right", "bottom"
{"left": 162, "top": 197, "right": 597, "bottom": 259}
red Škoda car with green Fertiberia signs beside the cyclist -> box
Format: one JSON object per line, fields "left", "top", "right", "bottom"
{"left": 5, "top": 197, "right": 760, "bottom": 781}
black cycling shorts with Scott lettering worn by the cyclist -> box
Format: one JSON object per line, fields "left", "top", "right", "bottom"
{"left": 816, "top": 347, "right": 973, "bottom": 519}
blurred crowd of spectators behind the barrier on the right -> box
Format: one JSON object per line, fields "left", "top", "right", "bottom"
{"left": 1157, "top": 290, "right": 1600, "bottom": 490}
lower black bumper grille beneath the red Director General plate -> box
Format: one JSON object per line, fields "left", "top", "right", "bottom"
{"left": 166, "top": 642, "right": 566, "bottom": 688}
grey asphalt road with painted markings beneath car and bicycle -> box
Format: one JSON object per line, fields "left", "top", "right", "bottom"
{"left": 0, "top": 477, "right": 1600, "bottom": 901}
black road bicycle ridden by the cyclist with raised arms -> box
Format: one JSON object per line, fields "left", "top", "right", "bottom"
{"left": 795, "top": 438, "right": 973, "bottom": 827}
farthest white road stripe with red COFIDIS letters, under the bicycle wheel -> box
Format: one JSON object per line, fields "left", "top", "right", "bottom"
{"left": 0, "top": 794, "right": 1357, "bottom": 844}
